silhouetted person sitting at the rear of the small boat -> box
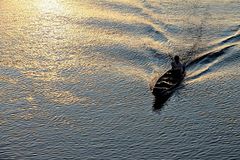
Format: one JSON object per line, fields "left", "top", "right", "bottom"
{"left": 171, "top": 56, "right": 185, "bottom": 77}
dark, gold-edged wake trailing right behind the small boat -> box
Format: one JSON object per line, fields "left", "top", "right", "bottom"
{"left": 186, "top": 29, "right": 240, "bottom": 81}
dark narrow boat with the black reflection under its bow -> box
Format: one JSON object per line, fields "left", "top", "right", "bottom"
{"left": 152, "top": 69, "right": 186, "bottom": 107}
